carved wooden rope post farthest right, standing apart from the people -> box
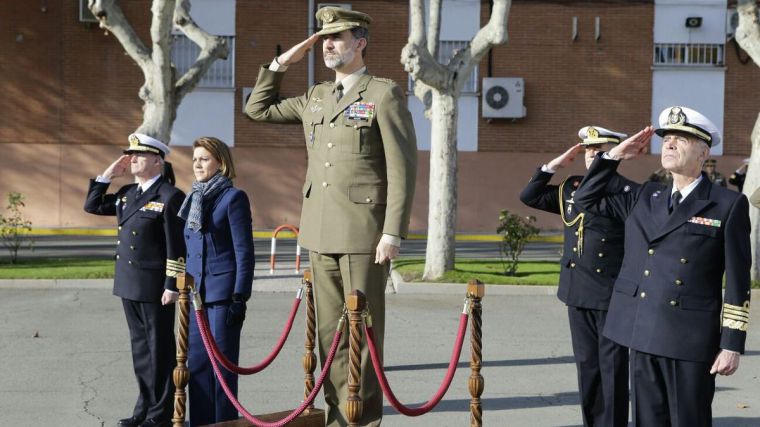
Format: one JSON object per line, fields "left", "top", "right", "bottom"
{"left": 467, "top": 280, "right": 485, "bottom": 427}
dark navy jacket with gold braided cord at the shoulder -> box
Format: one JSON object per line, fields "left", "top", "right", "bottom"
{"left": 520, "top": 169, "right": 638, "bottom": 310}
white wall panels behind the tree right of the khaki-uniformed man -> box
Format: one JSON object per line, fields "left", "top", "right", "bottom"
{"left": 408, "top": 0, "right": 480, "bottom": 151}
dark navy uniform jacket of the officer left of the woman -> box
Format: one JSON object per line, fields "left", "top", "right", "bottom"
{"left": 84, "top": 178, "right": 185, "bottom": 302}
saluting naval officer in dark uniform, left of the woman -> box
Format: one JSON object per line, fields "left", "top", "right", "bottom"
{"left": 84, "top": 134, "right": 185, "bottom": 427}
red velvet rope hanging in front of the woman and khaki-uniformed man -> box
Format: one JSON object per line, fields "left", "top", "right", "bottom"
{"left": 195, "top": 309, "right": 343, "bottom": 427}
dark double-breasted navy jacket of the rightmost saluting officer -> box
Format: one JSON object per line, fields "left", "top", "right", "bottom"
{"left": 575, "top": 158, "right": 752, "bottom": 362}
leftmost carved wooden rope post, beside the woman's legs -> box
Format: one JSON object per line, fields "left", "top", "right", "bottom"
{"left": 172, "top": 274, "right": 193, "bottom": 427}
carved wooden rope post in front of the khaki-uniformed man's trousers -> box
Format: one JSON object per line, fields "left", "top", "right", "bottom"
{"left": 346, "top": 291, "right": 367, "bottom": 427}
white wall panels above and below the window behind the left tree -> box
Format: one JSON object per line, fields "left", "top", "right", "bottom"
{"left": 171, "top": 0, "right": 236, "bottom": 146}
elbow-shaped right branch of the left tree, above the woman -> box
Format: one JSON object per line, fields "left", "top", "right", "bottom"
{"left": 174, "top": 0, "right": 229, "bottom": 102}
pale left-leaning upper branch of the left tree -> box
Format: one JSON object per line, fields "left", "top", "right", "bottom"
{"left": 87, "top": 0, "right": 150, "bottom": 67}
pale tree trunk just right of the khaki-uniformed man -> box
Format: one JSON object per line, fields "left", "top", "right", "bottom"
{"left": 423, "top": 90, "right": 458, "bottom": 280}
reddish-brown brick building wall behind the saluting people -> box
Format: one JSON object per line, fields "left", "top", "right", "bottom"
{"left": 0, "top": 0, "right": 760, "bottom": 232}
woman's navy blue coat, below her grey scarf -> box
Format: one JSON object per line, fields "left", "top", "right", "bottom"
{"left": 185, "top": 187, "right": 255, "bottom": 303}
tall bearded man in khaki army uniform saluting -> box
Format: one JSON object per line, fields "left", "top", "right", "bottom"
{"left": 246, "top": 7, "right": 417, "bottom": 426}
